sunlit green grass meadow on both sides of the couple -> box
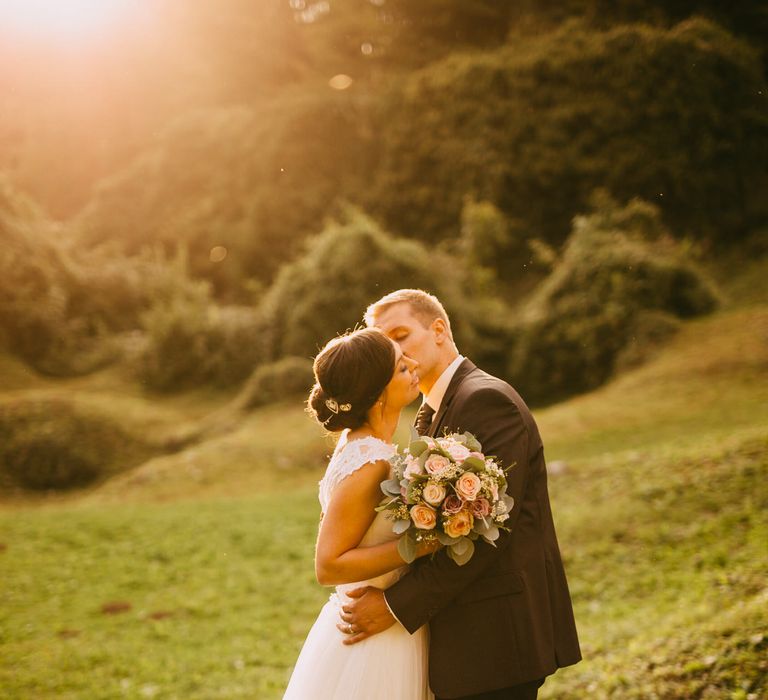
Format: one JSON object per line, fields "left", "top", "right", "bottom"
{"left": 0, "top": 260, "right": 768, "bottom": 700}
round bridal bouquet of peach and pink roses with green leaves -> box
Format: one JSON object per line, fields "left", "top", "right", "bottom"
{"left": 377, "top": 433, "right": 514, "bottom": 565}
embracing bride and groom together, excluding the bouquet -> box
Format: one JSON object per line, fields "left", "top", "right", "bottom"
{"left": 284, "top": 289, "right": 581, "bottom": 700}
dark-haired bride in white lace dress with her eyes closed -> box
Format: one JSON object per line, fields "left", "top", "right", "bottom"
{"left": 283, "top": 328, "right": 434, "bottom": 700}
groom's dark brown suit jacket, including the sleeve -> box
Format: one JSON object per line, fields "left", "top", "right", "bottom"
{"left": 385, "top": 360, "right": 581, "bottom": 698}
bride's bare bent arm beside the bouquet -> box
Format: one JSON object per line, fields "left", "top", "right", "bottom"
{"left": 315, "top": 461, "right": 437, "bottom": 586}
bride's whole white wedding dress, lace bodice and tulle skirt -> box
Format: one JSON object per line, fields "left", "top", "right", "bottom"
{"left": 283, "top": 431, "right": 434, "bottom": 700}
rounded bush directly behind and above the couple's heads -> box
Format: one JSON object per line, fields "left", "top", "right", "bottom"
{"left": 261, "top": 206, "right": 472, "bottom": 359}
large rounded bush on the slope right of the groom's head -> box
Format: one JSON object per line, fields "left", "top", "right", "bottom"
{"left": 509, "top": 197, "right": 717, "bottom": 403}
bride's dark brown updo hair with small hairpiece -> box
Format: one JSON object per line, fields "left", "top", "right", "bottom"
{"left": 307, "top": 328, "right": 395, "bottom": 432}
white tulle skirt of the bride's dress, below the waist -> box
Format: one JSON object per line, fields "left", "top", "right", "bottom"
{"left": 283, "top": 593, "right": 434, "bottom": 700}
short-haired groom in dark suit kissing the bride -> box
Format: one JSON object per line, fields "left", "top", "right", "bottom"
{"left": 339, "top": 289, "right": 581, "bottom": 700}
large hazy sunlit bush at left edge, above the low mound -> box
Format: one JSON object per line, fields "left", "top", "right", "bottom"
{"left": 0, "top": 178, "right": 240, "bottom": 378}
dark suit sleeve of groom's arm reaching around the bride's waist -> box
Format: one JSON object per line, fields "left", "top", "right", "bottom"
{"left": 384, "top": 388, "right": 529, "bottom": 633}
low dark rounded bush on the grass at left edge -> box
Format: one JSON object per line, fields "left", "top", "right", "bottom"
{"left": 0, "top": 399, "right": 150, "bottom": 490}
